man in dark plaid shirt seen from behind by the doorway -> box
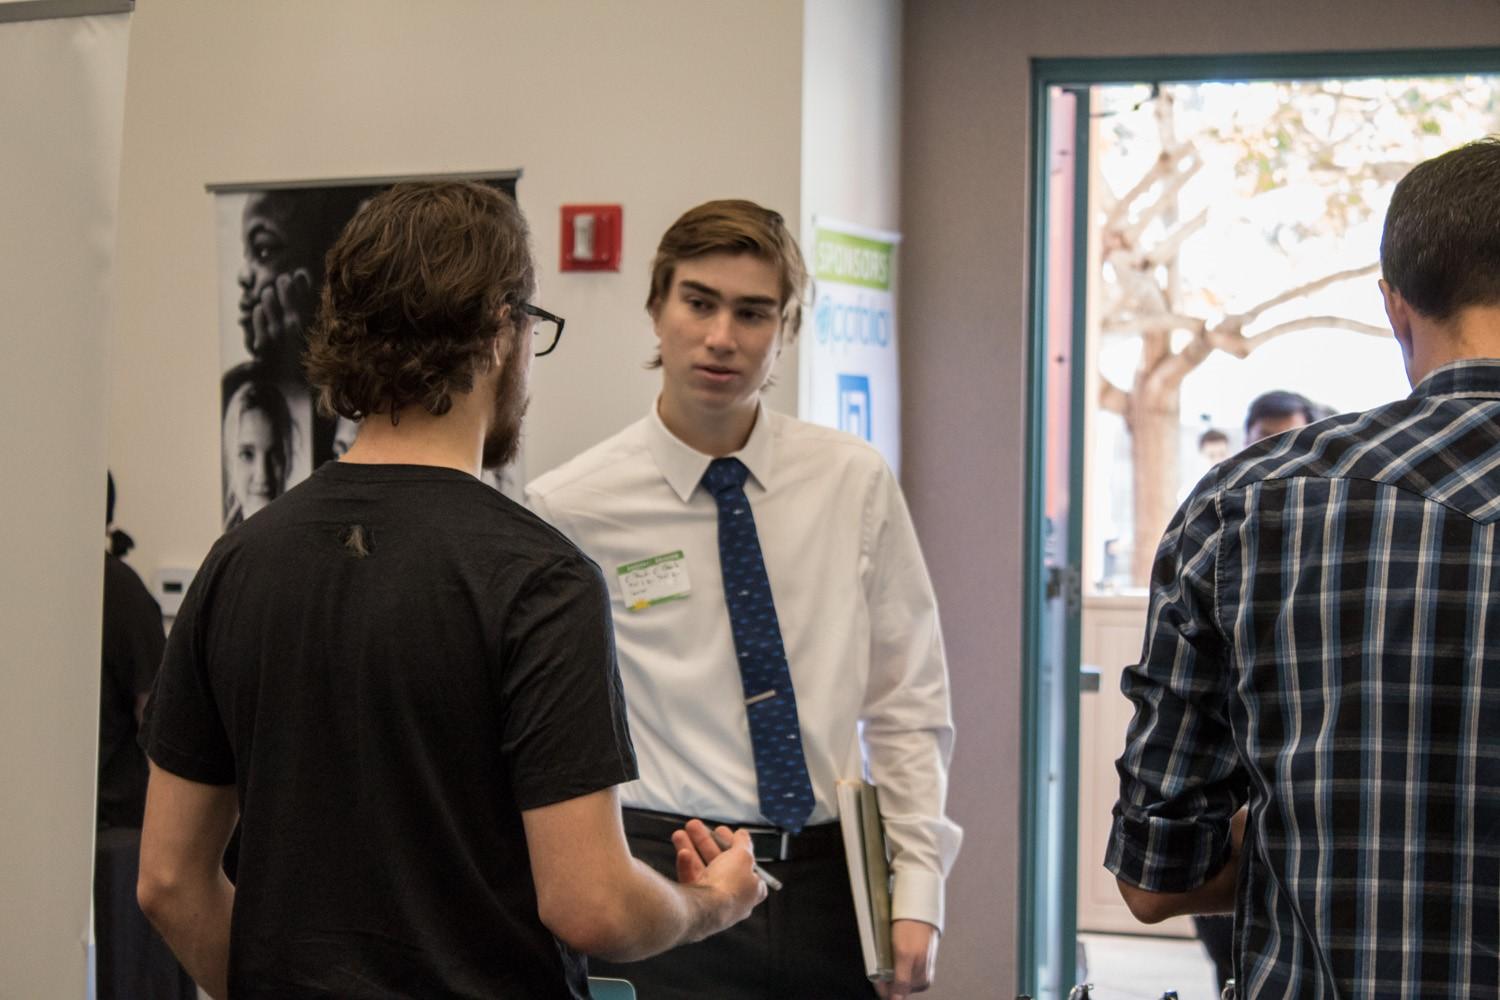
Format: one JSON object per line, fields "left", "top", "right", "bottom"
{"left": 1106, "top": 139, "right": 1500, "bottom": 1000}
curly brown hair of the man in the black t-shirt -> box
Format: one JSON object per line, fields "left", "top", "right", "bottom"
{"left": 305, "top": 181, "right": 536, "bottom": 420}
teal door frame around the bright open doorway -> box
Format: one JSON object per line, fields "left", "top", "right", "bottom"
{"left": 1016, "top": 48, "right": 1500, "bottom": 996}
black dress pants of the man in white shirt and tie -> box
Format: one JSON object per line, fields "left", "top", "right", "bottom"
{"left": 588, "top": 816, "right": 876, "bottom": 1000}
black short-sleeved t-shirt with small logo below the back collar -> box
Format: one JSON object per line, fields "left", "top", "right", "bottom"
{"left": 147, "top": 463, "right": 636, "bottom": 1000}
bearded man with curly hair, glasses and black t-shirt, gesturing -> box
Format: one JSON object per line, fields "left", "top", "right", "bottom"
{"left": 140, "top": 181, "right": 765, "bottom": 1000}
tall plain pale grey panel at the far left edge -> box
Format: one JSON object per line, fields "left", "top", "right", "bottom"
{"left": 0, "top": 15, "right": 129, "bottom": 999}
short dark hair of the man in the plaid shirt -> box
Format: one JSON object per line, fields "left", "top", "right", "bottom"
{"left": 1380, "top": 136, "right": 1500, "bottom": 321}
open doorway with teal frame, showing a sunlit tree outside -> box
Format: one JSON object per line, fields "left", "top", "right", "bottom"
{"left": 1019, "top": 51, "right": 1500, "bottom": 1000}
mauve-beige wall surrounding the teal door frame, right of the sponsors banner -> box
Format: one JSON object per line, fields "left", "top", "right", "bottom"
{"left": 900, "top": 0, "right": 1500, "bottom": 1000}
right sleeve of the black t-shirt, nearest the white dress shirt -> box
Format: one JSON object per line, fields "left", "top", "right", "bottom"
{"left": 497, "top": 555, "right": 638, "bottom": 810}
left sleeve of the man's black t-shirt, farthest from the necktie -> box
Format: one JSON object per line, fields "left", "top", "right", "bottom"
{"left": 141, "top": 551, "right": 234, "bottom": 784}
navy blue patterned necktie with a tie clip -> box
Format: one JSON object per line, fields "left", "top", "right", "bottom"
{"left": 704, "top": 459, "right": 813, "bottom": 834}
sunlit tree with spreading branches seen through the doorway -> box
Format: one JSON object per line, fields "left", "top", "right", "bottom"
{"left": 1091, "top": 83, "right": 1500, "bottom": 586}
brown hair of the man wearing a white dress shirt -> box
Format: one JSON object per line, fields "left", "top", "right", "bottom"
{"left": 647, "top": 198, "right": 807, "bottom": 340}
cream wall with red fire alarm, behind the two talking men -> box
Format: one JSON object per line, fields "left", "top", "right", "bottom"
{"left": 108, "top": 0, "right": 803, "bottom": 577}
